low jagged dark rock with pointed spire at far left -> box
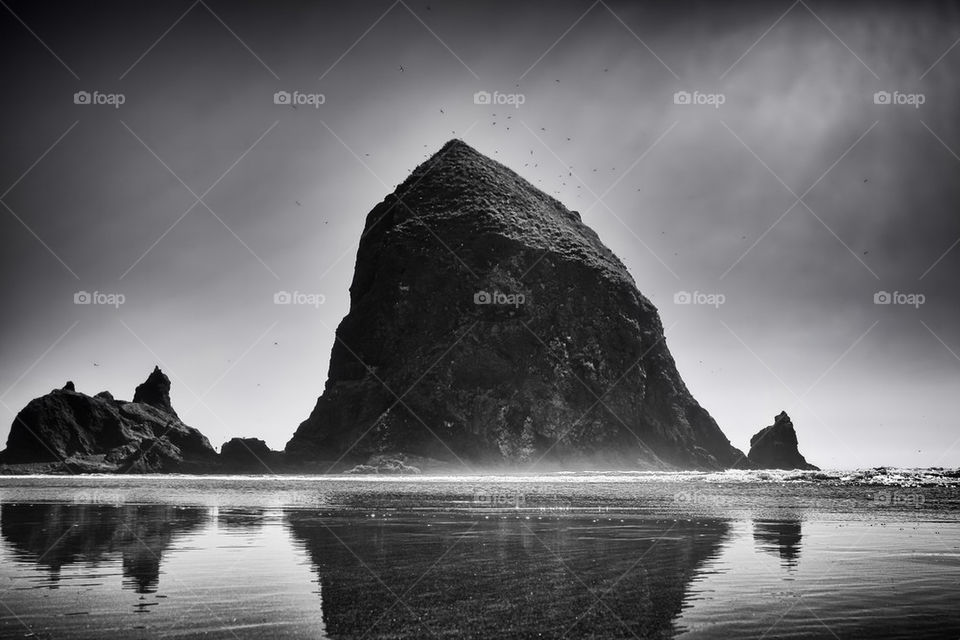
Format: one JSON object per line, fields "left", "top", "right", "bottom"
{"left": 0, "top": 369, "right": 216, "bottom": 473}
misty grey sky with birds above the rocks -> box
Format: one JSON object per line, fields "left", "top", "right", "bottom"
{"left": 0, "top": 0, "right": 960, "bottom": 468}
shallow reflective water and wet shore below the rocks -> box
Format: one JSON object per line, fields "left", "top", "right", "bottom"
{"left": 0, "top": 471, "right": 960, "bottom": 638}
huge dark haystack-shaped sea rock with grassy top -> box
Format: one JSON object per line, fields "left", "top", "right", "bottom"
{"left": 286, "top": 140, "right": 743, "bottom": 469}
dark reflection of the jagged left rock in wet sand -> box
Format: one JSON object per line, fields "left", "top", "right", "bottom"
{"left": 0, "top": 504, "right": 207, "bottom": 593}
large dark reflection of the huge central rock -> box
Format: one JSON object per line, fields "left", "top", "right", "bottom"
{"left": 287, "top": 511, "right": 729, "bottom": 638}
